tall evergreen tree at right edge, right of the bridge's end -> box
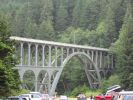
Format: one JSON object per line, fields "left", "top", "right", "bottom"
{"left": 113, "top": 2, "right": 133, "bottom": 90}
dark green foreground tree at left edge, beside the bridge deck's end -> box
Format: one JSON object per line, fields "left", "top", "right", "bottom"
{"left": 0, "top": 18, "right": 20, "bottom": 96}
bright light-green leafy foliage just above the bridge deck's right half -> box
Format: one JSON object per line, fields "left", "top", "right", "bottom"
{"left": 59, "top": 27, "right": 105, "bottom": 47}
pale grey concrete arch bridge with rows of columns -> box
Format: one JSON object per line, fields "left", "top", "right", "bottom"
{"left": 10, "top": 36, "right": 114, "bottom": 95}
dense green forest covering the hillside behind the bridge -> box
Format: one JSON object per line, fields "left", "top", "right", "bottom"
{"left": 0, "top": 0, "right": 133, "bottom": 96}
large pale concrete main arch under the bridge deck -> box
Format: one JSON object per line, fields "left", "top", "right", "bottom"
{"left": 50, "top": 52, "right": 101, "bottom": 95}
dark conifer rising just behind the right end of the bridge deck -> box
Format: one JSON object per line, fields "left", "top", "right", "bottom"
{"left": 102, "top": 6, "right": 118, "bottom": 48}
